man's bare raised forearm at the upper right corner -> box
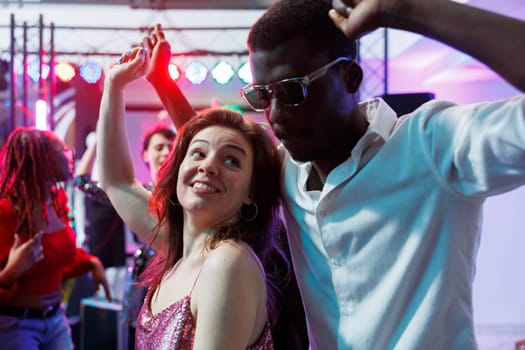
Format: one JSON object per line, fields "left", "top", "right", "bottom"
{"left": 392, "top": 0, "right": 525, "bottom": 91}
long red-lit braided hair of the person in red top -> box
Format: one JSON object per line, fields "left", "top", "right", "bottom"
{"left": 0, "top": 127, "right": 68, "bottom": 237}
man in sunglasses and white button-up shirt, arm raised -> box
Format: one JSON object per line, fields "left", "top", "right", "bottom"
{"left": 145, "top": 0, "right": 525, "bottom": 350}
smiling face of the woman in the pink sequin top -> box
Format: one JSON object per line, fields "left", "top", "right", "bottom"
{"left": 177, "top": 126, "right": 253, "bottom": 227}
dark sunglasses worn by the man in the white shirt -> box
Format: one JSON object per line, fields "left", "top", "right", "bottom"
{"left": 241, "top": 57, "right": 352, "bottom": 112}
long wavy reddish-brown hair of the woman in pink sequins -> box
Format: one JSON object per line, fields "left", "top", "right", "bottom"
{"left": 143, "top": 108, "right": 289, "bottom": 321}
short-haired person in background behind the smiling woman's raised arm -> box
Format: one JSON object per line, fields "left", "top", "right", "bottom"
{"left": 74, "top": 123, "right": 175, "bottom": 339}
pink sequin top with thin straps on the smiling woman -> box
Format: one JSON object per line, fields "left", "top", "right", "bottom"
{"left": 135, "top": 270, "right": 273, "bottom": 350}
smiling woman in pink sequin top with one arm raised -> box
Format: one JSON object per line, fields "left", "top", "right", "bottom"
{"left": 97, "top": 48, "right": 282, "bottom": 349}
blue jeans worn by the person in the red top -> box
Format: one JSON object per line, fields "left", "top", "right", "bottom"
{"left": 0, "top": 306, "right": 74, "bottom": 350}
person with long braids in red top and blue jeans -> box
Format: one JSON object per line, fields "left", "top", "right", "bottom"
{"left": 0, "top": 127, "right": 111, "bottom": 350}
